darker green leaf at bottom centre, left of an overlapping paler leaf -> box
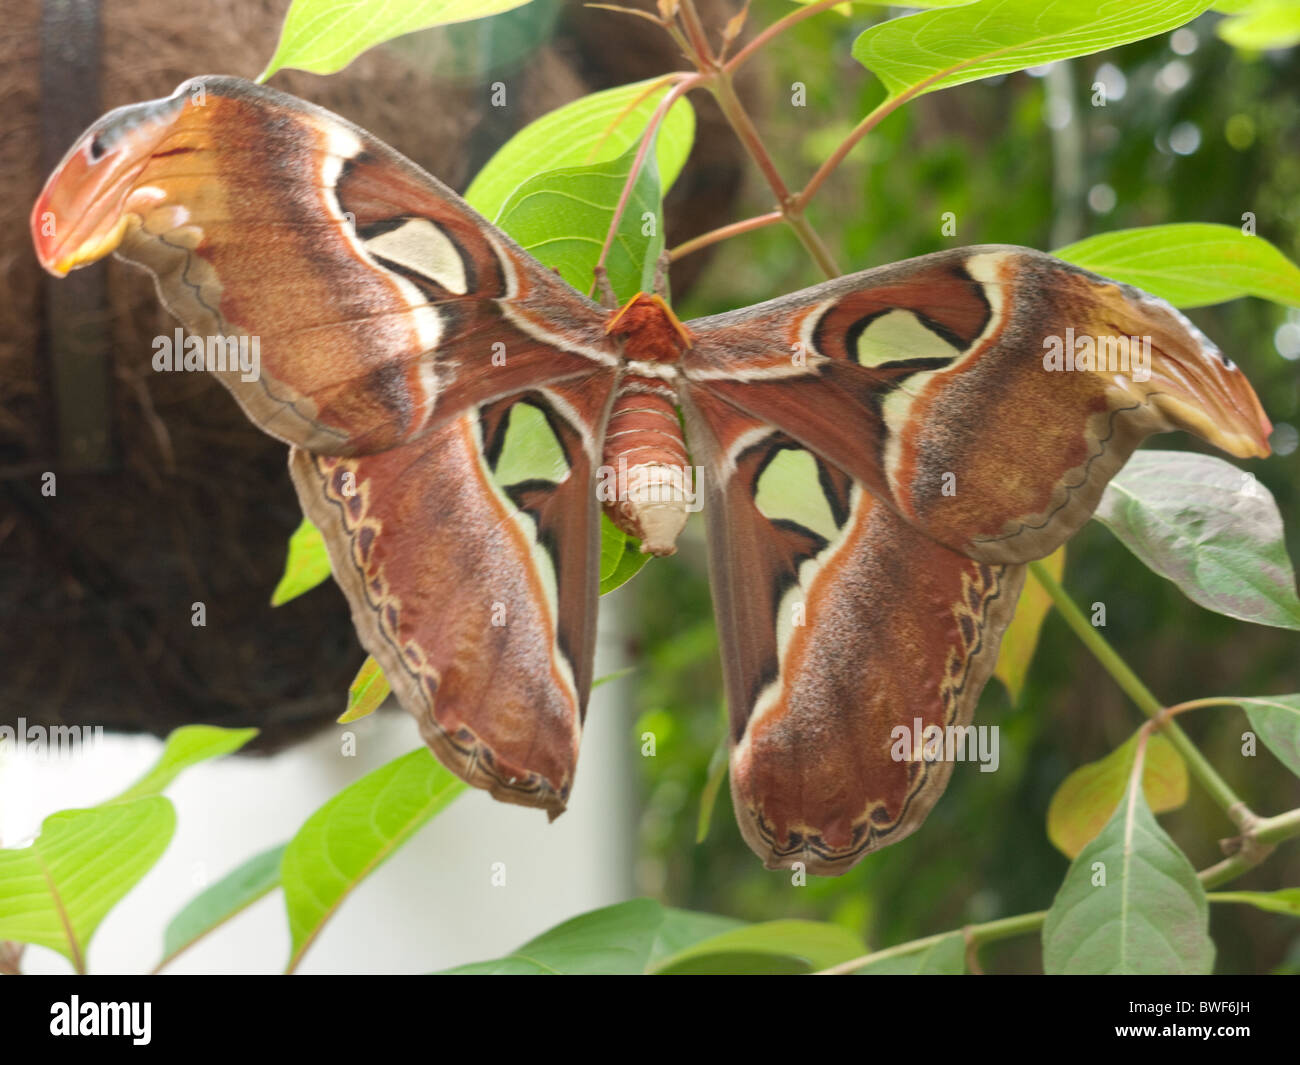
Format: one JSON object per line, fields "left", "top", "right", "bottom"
{"left": 449, "top": 899, "right": 741, "bottom": 977}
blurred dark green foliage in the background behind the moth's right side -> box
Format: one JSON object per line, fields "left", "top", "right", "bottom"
{"left": 616, "top": 0, "right": 1300, "bottom": 973}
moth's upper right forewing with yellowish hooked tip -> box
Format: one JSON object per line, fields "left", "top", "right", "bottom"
{"left": 684, "top": 246, "right": 1271, "bottom": 563}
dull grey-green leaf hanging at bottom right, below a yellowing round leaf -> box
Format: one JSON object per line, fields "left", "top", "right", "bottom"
{"left": 1043, "top": 764, "right": 1214, "bottom": 975}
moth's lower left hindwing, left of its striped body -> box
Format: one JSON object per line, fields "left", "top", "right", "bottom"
{"left": 290, "top": 385, "right": 610, "bottom": 818}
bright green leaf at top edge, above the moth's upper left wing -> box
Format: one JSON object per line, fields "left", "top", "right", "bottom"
{"left": 257, "top": 0, "right": 528, "bottom": 82}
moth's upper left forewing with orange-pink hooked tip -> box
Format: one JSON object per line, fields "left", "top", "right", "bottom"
{"left": 31, "top": 77, "right": 616, "bottom": 455}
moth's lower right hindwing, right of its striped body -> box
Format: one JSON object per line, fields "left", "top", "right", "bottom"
{"left": 685, "top": 391, "right": 1024, "bottom": 875}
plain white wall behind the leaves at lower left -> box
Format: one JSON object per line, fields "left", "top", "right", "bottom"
{"left": 0, "top": 621, "right": 637, "bottom": 973}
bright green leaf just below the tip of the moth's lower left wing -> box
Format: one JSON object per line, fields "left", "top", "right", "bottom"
{"left": 281, "top": 748, "right": 465, "bottom": 971}
